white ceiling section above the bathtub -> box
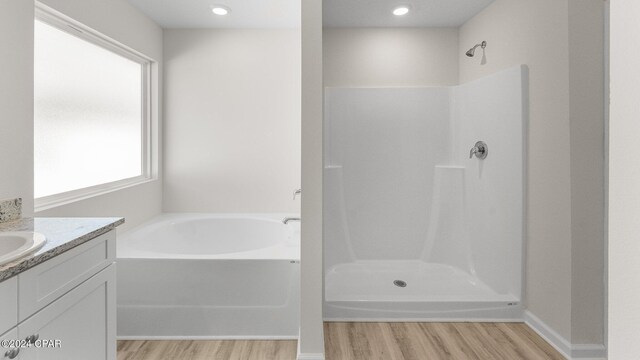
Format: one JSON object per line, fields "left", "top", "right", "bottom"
{"left": 128, "top": 0, "right": 300, "bottom": 29}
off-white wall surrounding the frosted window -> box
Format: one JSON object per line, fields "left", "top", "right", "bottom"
{"left": 34, "top": 0, "right": 162, "bottom": 231}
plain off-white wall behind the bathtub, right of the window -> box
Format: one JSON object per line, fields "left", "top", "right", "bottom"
{"left": 164, "top": 29, "right": 301, "bottom": 213}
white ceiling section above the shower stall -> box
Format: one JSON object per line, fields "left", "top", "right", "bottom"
{"left": 323, "top": 0, "right": 494, "bottom": 27}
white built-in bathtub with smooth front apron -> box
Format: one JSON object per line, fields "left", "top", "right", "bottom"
{"left": 117, "top": 214, "right": 300, "bottom": 339}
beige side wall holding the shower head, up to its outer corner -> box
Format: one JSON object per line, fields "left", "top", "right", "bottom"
{"left": 458, "top": 0, "right": 571, "bottom": 339}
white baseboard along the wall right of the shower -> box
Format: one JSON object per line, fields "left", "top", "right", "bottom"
{"left": 524, "top": 310, "right": 606, "bottom": 360}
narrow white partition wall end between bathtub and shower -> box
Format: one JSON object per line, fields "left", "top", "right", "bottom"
{"left": 298, "top": 0, "right": 324, "bottom": 360}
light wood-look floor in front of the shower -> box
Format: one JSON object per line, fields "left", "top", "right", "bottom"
{"left": 324, "top": 323, "right": 564, "bottom": 360}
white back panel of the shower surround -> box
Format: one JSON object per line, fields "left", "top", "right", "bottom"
{"left": 325, "top": 87, "right": 452, "bottom": 262}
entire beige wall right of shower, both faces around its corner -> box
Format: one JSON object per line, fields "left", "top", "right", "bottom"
{"left": 458, "top": 0, "right": 604, "bottom": 344}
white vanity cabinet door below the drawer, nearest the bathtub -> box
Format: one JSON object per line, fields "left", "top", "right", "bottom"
{"left": 18, "top": 264, "right": 116, "bottom": 360}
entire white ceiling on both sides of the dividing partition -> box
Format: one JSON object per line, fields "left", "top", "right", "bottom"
{"left": 128, "top": 0, "right": 494, "bottom": 29}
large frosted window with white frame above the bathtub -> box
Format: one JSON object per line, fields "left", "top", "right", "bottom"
{"left": 34, "top": 13, "right": 150, "bottom": 209}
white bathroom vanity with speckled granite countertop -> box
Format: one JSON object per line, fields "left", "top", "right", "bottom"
{"left": 0, "top": 218, "right": 124, "bottom": 360}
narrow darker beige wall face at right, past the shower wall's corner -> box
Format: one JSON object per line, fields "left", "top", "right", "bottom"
{"left": 569, "top": 0, "right": 606, "bottom": 344}
